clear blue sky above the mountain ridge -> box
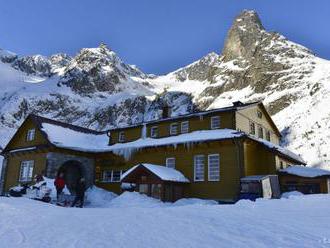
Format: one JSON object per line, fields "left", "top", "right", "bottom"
{"left": 0, "top": 0, "right": 330, "bottom": 74}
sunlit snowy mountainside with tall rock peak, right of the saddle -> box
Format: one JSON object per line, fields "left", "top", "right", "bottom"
{"left": 148, "top": 11, "right": 330, "bottom": 168}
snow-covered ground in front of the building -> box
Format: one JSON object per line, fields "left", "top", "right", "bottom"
{"left": 0, "top": 193, "right": 330, "bottom": 248}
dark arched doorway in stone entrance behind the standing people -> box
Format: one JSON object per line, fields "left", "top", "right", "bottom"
{"left": 57, "top": 160, "right": 84, "bottom": 193}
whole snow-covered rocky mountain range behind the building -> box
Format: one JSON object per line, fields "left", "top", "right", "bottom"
{"left": 0, "top": 11, "right": 330, "bottom": 169}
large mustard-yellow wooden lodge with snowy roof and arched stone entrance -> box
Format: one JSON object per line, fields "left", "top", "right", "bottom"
{"left": 2, "top": 102, "right": 304, "bottom": 201}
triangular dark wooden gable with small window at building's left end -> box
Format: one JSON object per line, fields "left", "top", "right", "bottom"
{"left": 3, "top": 117, "right": 48, "bottom": 152}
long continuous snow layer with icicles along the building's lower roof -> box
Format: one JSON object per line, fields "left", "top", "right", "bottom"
{"left": 40, "top": 119, "right": 305, "bottom": 164}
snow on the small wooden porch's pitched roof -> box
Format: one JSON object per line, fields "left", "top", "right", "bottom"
{"left": 120, "top": 163, "right": 189, "bottom": 183}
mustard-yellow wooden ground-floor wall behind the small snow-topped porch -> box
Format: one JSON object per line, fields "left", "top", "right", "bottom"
{"left": 96, "top": 140, "right": 240, "bottom": 200}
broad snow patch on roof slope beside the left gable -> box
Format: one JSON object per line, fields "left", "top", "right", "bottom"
{"left": 41, "top": 123, "right": 109, "bottom": 152}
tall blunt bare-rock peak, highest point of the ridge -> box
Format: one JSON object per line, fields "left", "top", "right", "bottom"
{"left": 222, "top": 10, "right": 264, "bottom": 61}
